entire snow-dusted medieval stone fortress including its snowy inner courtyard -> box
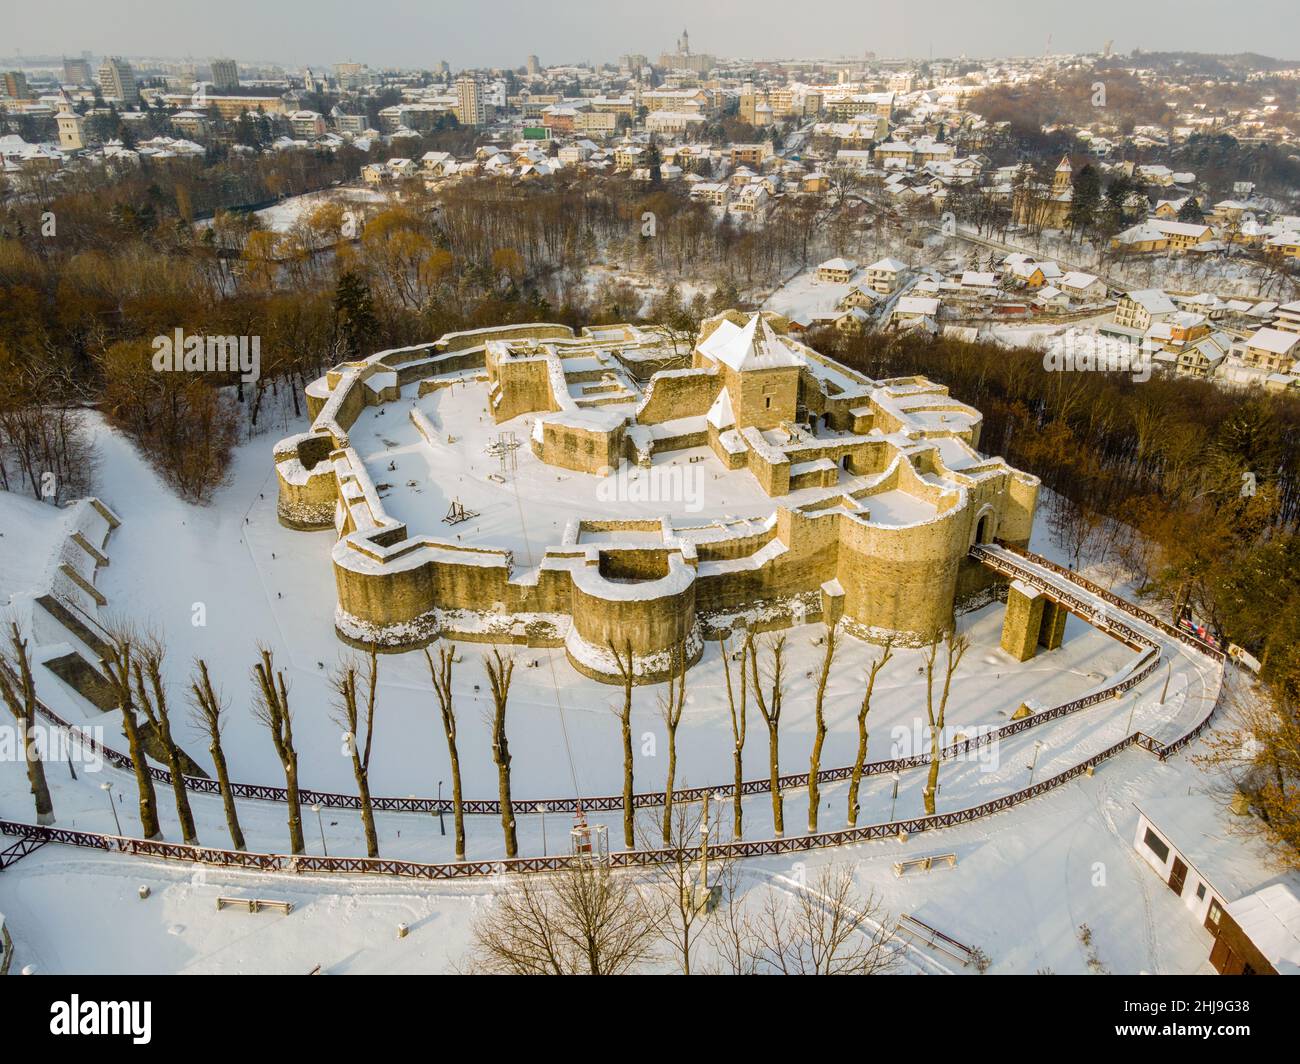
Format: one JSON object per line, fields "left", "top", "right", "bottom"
{"left": 274, "top": 311, "right": 1039, "bottom": 683}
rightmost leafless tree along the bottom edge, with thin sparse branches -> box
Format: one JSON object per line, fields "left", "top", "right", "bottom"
{"left": 754, "top": 865, "right": 898, "bottom": 976}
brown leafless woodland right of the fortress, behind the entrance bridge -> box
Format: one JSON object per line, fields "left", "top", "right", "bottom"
{"left": 836, "top": 329, "right": 1300, "bottom": 860}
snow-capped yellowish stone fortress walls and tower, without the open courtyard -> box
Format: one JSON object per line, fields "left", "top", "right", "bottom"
{"left": 274, "top": 311, "right": 1039, "bottom": 682}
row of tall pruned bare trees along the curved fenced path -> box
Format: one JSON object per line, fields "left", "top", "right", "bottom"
{"left": 0, "top": 613, "right": 969, "bottom": 861}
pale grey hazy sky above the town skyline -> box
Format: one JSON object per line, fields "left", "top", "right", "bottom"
{"left": 0, "top": 0, "right": 1300, "bottom": 68}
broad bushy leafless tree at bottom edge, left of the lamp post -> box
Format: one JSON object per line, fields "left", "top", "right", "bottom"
{"left": 472, "top": 858, "right": 657, "bottom": 976}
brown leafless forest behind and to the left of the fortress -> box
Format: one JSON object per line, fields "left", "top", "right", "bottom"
{"left": 0, "top": 152, "right": 852, "bottom": 501}
